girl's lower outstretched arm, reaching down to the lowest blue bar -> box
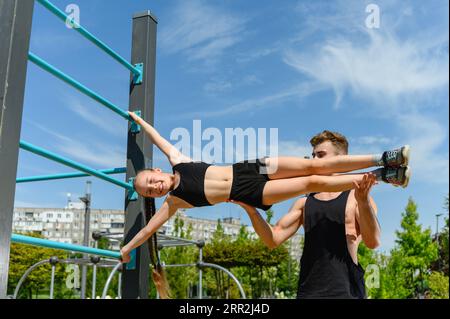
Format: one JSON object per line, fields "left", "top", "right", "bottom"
{"left": 120, "top": 196, "right": 180, "bottom": 263}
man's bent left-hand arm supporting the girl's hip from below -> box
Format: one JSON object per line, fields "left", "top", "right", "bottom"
{"left": 231, "top": 198, "right": 305, "bottom": 249}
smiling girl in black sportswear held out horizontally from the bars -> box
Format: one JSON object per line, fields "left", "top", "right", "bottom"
{"left": 121, "top": 112, "right": 410, "bottom": 262}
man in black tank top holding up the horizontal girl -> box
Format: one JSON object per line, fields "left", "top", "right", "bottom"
{"left": 232, "top": 131, "right": 380, "bottom": 298}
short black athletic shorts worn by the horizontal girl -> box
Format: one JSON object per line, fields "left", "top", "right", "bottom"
{"left": 230, "top": 159, "right": 272, "bottom": 210}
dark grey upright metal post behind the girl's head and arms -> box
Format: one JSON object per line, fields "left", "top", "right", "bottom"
{"left": 122, "top": 11, "right": 157, "bottom": 299}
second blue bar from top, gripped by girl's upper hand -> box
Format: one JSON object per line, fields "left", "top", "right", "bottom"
{"left": 28, "top": 52, "right": 132, "bottom": 121}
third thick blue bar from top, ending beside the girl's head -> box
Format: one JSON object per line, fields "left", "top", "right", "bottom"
{"left": 19, "top": 141, "right": 134, "bottom": 191}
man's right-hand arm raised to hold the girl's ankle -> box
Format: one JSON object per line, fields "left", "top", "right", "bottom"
{"left": 355, "top": 175, "right": 381, "bottom": 249}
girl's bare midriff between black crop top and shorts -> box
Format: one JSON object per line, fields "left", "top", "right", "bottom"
{"left": 205, "top": 165, "right": 233, "bottom": 204}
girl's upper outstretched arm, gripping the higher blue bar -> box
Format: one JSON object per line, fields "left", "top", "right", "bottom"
{"left": 128, "top": 112, "right": 192, "bottom": 166}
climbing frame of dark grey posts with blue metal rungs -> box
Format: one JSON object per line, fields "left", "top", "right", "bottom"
{"left": 0, "top": 0, "right": 157, "bottom": 299}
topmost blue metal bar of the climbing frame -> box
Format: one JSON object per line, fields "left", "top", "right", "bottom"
{"left": 37, "top": 0, "right": 142, "bottom": 76}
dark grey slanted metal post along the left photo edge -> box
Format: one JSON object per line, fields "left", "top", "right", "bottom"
{"left": 0, "top": 0, "right": 34, "bottom": 299}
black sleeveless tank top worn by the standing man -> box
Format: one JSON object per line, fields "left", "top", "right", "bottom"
{"left": 297, "top": 191, "right": 366, "bottom": 299}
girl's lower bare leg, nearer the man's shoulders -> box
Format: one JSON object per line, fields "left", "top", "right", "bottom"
{"left": 263, "top": 173, "right": 370, "bottom": 205}
